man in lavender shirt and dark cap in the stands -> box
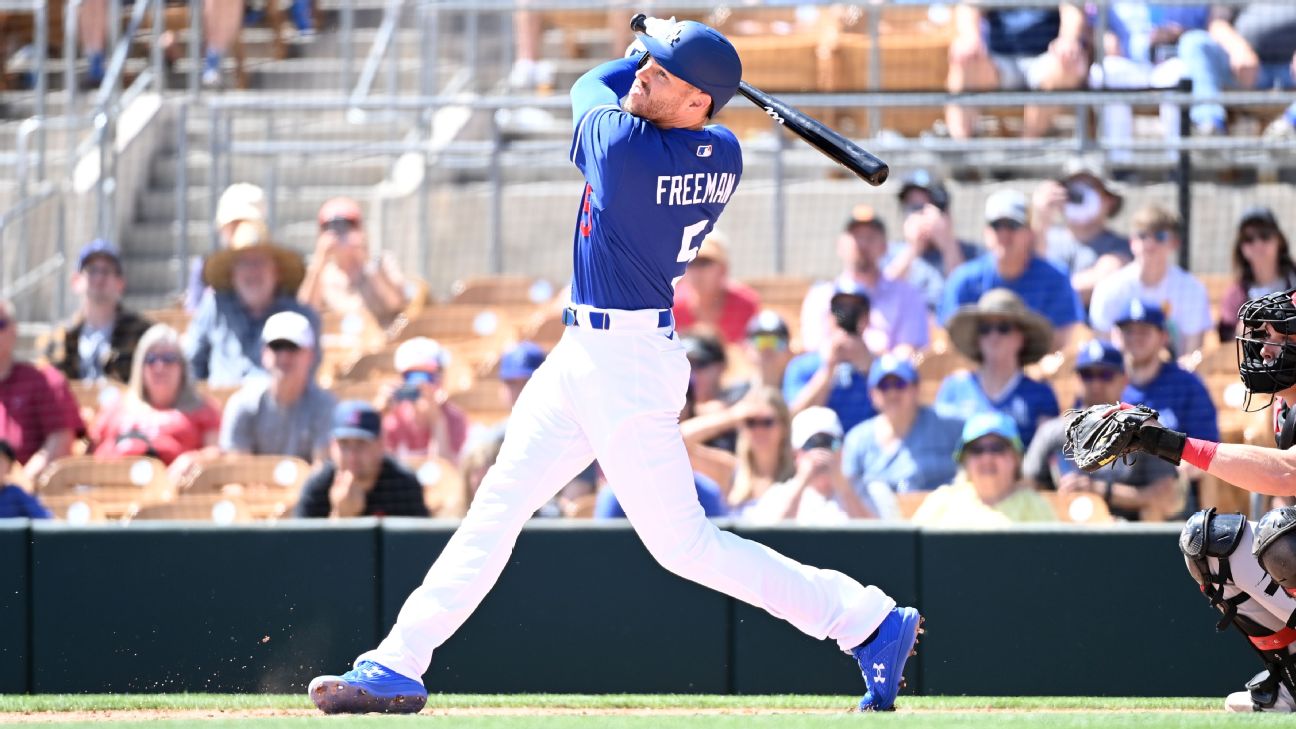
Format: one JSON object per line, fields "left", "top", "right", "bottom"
{"left": 801, "top": 205, "right": 927, "bottom": 357}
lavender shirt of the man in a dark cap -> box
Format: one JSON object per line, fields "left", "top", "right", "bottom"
{"left": 801, "top": 276, "right": 928, "bottom": 354}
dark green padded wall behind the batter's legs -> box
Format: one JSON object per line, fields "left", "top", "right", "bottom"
{"left": 0, "top": 519, "right": 1260, "bottom": 695}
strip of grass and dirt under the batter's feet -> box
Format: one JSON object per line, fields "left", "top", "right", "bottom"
{"left": 0, "top": 694, "right": 1275, "bottom": 729}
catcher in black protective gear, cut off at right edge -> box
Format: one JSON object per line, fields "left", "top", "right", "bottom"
{"left": 1067, "top": 289, "right": 1296, "bottom": 712}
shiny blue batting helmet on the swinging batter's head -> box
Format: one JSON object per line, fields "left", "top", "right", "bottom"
{"left": 639, "top": 21, "right": 743, "bottom": 114}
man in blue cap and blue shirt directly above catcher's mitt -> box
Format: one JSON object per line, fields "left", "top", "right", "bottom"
{"left": 1116, "top": 298, "right": 1220, "bottom": 442}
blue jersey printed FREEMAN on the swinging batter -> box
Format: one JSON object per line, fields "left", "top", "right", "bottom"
{"left": 572, "top": 58, "right": 743, "bottom": 310}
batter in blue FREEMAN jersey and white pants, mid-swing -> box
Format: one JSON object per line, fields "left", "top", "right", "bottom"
{"left": 308, "top": 21, "right": 921, "bottom": 713}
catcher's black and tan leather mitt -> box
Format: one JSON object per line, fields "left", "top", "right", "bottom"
{"left": 1064, "top": 402, "right": 1166, "bottom": 473}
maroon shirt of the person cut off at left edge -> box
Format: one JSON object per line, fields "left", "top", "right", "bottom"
{"left": 0, "top": 362, "right": 86, "bottom": 463}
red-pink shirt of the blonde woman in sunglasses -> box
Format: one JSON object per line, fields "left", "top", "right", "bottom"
{"left": 89, "top": 397, "right": 220, "bottom": 464}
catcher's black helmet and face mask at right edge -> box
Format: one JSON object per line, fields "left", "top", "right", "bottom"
{"left": 1236, "top": 289, "right": 1296, "bottom": 411}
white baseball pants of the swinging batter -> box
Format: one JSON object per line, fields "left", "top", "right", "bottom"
{"left": 360, "top": 307, "right": 896, "bottom": 678}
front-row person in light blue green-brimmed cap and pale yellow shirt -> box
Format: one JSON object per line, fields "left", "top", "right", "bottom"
{"left": 914, "top": 411, "right": 1056, "bottom": 528}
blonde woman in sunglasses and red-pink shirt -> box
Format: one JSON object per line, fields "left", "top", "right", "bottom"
{"left": 89, "top": 324, "right": 220, "bottom": 464}
